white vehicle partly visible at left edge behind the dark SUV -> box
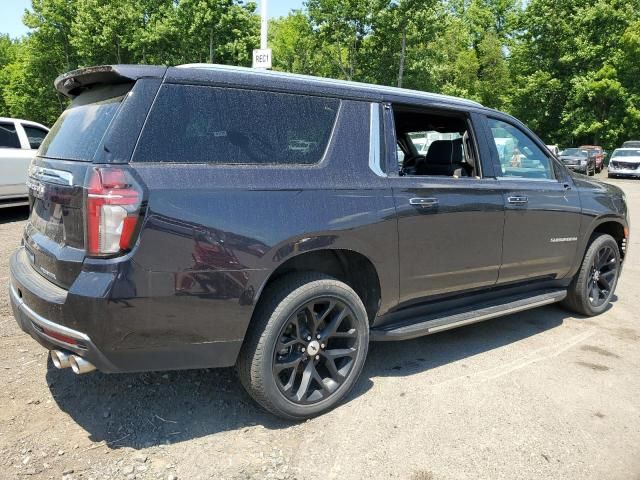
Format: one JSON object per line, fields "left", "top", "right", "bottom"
{"left": 0, "top": 117, "right": 49, "bottom": 208}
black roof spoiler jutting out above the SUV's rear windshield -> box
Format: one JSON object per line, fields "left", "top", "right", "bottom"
{"left": 53, "top": 65, "right": 167, "bottom": 98}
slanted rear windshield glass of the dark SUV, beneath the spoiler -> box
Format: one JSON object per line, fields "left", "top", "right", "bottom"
{"left": 38, "top": 84, "right": 131, "bottom": 162}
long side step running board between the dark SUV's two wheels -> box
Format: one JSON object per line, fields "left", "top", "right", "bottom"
{"left": 370, "top": 290, "right": 567, "bottom": 341}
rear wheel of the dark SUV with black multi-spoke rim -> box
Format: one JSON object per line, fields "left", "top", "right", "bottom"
{"left": 236, "top": 272, "right": 369, "bottom": 420}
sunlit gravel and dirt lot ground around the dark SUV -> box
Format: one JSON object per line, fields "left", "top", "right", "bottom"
{"left": 0, "top": 171, "right": 640, "bottom": 480}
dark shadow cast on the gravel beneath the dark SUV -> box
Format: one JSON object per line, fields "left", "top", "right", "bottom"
{"left": 47, "top": 306, "right": 570, "bottom": 448}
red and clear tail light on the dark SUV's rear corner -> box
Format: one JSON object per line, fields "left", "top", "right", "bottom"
{"left": 87, "top": 167, "right": 142, "bottom": 255}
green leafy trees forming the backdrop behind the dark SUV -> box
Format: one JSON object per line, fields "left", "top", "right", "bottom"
{"left": 0, "top": 0, "right": 640, "bottom": 148}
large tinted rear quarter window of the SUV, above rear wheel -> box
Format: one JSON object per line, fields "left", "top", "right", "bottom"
{"left": 133, "top": 85, "right": 340, "bottom": 165}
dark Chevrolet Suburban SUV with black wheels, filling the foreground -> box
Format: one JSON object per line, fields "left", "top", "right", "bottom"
{"left": 10, "top": 65, "right": 628, "bottom": 419}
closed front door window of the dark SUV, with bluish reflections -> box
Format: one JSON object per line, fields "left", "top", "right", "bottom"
{"left": 487, "top": 118, "right": 555, "bottom": 179}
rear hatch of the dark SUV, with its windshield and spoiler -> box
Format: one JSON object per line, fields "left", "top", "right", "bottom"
{"left": 24, "top": 67, "right": 165, "bottom": 289}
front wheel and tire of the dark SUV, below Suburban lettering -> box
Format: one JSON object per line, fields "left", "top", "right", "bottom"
{"left": 563, "top": 234, "right": 620, "bottom": 317}
